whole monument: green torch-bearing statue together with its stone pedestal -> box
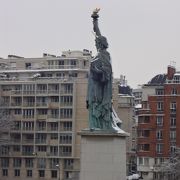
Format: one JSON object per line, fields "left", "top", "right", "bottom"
{"left": 79, "top": 9, "right": 128, "bottom": 180}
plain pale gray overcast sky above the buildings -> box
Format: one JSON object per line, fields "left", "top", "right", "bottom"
{"left": 0, "top": 0, "right": 180, "bottom": 88}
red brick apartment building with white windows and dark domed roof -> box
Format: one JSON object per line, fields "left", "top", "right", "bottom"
{"left": 137, "top": 66, "right": 180, "bottom": 180}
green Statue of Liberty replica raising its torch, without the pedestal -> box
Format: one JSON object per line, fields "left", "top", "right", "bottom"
{"left": 87, "top": 8, "right": 120, "bottom": 131}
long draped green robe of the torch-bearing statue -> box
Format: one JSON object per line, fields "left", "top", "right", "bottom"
{"left": 87, "top": 50, "right": 112, "bottom": 130}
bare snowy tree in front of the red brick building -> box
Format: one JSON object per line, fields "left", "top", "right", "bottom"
{"left": 160, "top": 147, "right": 180, "bottom": 180}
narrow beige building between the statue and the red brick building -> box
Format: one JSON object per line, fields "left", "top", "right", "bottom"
{"left": 113, "top": 75, "right": 136, "bottom": 174}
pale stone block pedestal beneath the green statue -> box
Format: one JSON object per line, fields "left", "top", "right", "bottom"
{"left": 79, "top": 130, "right": 127, "bottom": 180}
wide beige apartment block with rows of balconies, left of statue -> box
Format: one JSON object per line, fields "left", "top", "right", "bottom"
{"left": 0, "top": 50, "right": 92, "bottom": 180}
